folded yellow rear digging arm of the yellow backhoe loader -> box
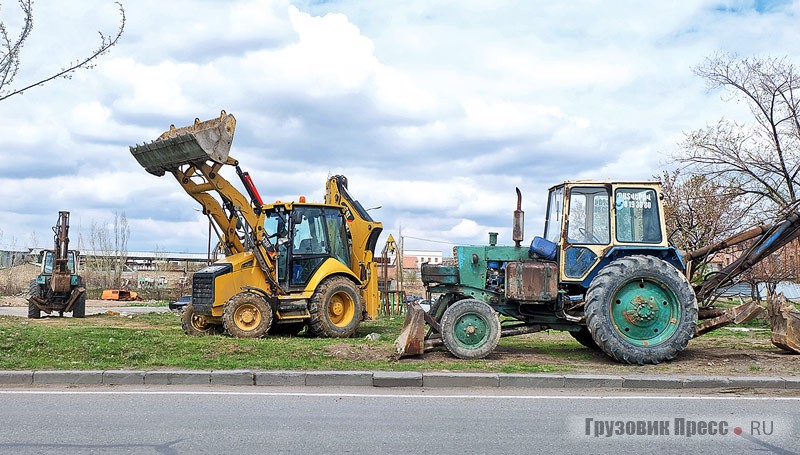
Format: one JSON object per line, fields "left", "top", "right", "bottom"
{"left": 325, "top": 175, "right": 383, "bottom": 319}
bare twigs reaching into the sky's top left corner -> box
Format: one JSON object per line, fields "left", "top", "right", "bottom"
{"left": 0, "top": 0, "right": 125, "bottom": 101}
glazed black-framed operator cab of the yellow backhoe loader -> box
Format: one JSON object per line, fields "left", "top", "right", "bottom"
{"left": 264, "top": 204, "right": 351, "bottom": 289}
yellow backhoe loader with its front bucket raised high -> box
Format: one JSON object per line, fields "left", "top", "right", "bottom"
{"left": 130, "top": 111, "right": 383, "bottom": 338}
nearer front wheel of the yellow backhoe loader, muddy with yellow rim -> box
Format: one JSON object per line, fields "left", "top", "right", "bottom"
{"left": 222, "top": 292, "right": 272, "bottom": 338}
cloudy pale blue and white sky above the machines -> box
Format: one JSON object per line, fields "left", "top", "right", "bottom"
{"left": 0, "top": 0, "right": 800, "bottom": 255}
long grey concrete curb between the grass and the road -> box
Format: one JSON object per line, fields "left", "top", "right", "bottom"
{"left": 0, "top": 370, "right": 800, "bottom": 390}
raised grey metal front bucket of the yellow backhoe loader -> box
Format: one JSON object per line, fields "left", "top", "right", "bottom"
{"left": 130, "top": 111, "right": 236, "bottom": 177}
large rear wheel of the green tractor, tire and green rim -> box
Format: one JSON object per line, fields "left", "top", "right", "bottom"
{"left": 585, "top": 256, "right": 697, "bottom": 365}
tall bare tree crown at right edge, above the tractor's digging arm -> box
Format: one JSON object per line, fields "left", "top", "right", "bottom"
{"left": 676, "top": 55, "right": 800, "bottom": 214}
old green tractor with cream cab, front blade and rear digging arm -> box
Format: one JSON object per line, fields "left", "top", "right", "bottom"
{"left": 396, "top": 181, "right": 800, "bottom": 364}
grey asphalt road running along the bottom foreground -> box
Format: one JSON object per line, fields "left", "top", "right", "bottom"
{"left": 0, "top": 386, "right": 800, "bottom": 454}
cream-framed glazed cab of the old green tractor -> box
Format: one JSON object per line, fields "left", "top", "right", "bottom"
{"left": 540, "top": 181, "right": 667, "bottom": 283}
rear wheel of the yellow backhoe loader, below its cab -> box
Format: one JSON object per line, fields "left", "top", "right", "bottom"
{"left": 308, "top": 276, "right": 364, "bottom": 338}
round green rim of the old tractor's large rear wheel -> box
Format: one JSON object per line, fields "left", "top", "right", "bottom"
{"left": 611, "top": 278, "right": 682, "bottom": 346}
